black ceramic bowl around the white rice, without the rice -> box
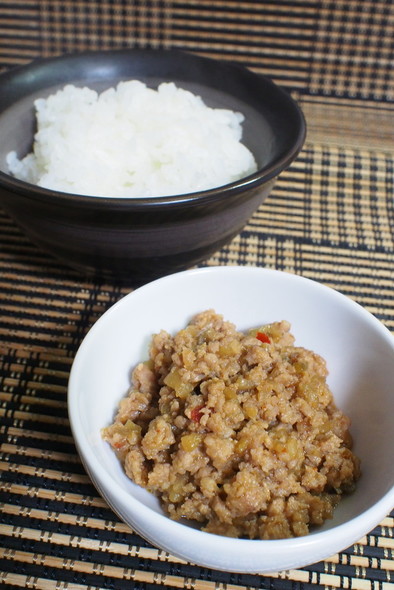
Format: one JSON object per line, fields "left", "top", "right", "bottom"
{"left": 0, "top": 49, "right": 305, "bottom": 283}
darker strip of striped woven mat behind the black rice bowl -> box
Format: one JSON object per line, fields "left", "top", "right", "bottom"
{"left": 0, "top": 0, "right": 394, "bottom": 102}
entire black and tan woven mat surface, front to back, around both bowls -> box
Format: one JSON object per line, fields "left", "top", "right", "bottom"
{"left": 0, "top": 0, "right": 394, "bottom": 590}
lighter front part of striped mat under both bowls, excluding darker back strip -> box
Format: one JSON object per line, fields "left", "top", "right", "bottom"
{"left": 0, "top": 97, "right": 394, "bottom": 590}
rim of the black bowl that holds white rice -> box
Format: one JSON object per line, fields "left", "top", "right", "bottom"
{"left": 0, "top": 48, "right": 306, "bottom": 210}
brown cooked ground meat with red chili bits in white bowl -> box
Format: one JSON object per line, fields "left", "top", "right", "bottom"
{"left": 103, "top": 310, "right": 360, "bottom": 539}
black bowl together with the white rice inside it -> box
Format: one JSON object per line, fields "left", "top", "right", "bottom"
{"left": 0, "top": 49, "right": 305, "bottom": 284}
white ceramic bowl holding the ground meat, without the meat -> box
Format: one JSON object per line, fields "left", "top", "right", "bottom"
{"left": 68, "top": 267, "right": 394, "bottom": 573}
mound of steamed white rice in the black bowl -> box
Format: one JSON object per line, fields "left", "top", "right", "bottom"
{"left": 7, "top": 80, "right": 256, "bottom": 197}
